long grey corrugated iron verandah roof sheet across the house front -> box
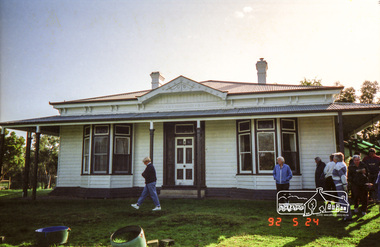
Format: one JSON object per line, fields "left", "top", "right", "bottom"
{"left": 0, "top": 103, "right": 380, "bottom": 127}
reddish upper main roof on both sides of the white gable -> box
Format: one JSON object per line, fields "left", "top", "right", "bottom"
{"left": 50, "top": 81, "right": 343, "bottom": 105}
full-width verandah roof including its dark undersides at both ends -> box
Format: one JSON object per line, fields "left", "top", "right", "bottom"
{"left": 0, "top": 103, "right": 380, "bottom": 135}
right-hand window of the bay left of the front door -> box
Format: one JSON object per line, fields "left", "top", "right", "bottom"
{"left": 112, "top": 125, "right": 132, "bottom": 174}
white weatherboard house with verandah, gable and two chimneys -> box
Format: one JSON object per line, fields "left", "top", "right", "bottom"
{"left": 0, "top": 59, "right": 380, "bottom": 199}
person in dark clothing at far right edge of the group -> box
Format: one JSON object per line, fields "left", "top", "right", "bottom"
{"left": 363, "top": 148, "right": 380, "bottom": 203}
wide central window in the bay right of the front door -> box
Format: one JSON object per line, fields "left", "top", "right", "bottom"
{"left": 256, "top": 119, "right": 276, "bottom": 172}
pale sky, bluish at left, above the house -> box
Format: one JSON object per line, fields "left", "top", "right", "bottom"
{"left": 0, "top": 0, "right": 380, "bottom": 121}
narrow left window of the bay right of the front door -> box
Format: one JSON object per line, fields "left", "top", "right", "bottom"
{"left": 237, "top": 120, "right": 253, "bottom": 173}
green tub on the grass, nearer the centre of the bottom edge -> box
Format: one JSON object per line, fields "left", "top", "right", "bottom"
{"left": 110, "top": 226, "right": 146, "bottom": 247}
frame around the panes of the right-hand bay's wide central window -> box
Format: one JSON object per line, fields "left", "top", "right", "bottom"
{"left": 255, "top": 118, "right": 278, "bottom": 175}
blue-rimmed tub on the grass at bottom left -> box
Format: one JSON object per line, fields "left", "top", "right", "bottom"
{"left": 36, "top": 226, "right": 71, "bottom": 246}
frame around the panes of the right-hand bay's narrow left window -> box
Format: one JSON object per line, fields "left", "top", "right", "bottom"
{"left": 236, "top": 119, "right": 254, "bottom": 175}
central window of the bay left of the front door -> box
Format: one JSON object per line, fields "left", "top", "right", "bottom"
{"left": 92, "top": 125, "right": 109, "bottom": 174}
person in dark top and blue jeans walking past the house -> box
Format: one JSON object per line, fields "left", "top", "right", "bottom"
{"left": 131, "top": 157, "right": 161, "bottom": 211}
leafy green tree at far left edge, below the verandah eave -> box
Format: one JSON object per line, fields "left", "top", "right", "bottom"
{"left": 1, "top": 130, "right": 25, "bottom": 188}
